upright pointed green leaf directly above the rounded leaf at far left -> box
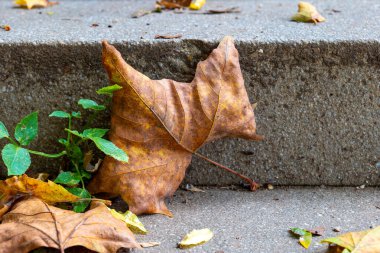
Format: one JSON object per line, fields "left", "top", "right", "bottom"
{"left": 15, "top": 112, "right": 38, "bottom": 146}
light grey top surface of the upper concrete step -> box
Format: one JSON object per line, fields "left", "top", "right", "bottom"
{"left": 0, "top": 0, "right": 380, "bottom": 44}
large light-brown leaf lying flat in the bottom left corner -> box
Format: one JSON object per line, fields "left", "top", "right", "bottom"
{"left": 0, "top": 197, "right": 140, "bottom": 253}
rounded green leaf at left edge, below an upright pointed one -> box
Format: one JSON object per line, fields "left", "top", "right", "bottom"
{"left": 1, "top": 144, "right": 31, "bottom": 176}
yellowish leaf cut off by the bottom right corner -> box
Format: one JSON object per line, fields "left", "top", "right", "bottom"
{"left": 321, "top": 226, "right": 380, "bottom": 253}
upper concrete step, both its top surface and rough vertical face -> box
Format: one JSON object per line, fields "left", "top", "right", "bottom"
{"left": 0, "top": 0, "right": 380, "bottom": 185}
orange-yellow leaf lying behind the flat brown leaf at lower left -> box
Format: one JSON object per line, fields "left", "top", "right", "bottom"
{"left": 0, "top": 174, "right": 79, "bottom": 205}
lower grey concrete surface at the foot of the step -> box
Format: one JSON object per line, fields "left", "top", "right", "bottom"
{"left": 119, "top": 188, "right": 380, "bottom": 253}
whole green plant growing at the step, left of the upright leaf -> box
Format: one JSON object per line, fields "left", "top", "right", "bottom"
{"left": 0, "top": 85, "right": 124, "bottom": 212}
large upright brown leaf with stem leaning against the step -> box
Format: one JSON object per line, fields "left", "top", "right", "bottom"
{"left": 89, "top": 37, "right": 261, "bottom": 216}
